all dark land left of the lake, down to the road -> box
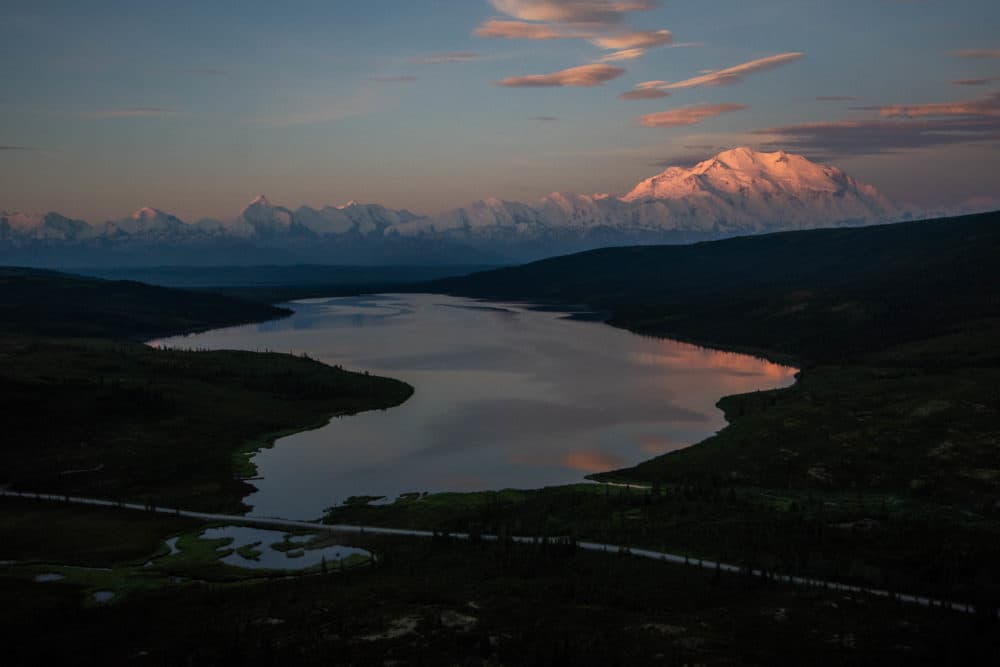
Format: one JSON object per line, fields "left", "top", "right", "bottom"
{"left": 0, "top": 269, "right": 413, "bottom": 511}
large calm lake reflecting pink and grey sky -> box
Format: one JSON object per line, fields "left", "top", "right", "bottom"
{"left": 154, "top": 294, "right": 796, "bottom": 519}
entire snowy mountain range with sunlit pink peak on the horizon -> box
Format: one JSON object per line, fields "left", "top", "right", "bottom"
{"left": 0, "top": 148, "right": 914, "bottom": 266}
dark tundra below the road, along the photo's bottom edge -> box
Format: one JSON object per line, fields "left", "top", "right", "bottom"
{"left": 0, "top": 500, "right": 1000, "bottom": 665}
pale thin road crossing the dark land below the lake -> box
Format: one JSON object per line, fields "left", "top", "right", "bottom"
{"left": 0, "top": 490, "right": 984, "bottom": 617}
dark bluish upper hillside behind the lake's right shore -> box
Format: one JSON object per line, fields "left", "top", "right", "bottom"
{"left": 433, "top": 213, "right": 1000, "bottom": 363}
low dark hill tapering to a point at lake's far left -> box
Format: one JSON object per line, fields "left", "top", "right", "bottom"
{"left": 0, "top": 267, "right": 291, "bottom": 340}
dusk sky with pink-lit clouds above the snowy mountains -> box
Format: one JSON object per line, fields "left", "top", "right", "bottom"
{"left": 0, "top": 0, "right": 1000, "bottom": 222}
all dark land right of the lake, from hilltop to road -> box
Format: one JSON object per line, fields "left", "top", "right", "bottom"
{"left": 322, "top": 214, "right": 1000, "bottom": 636}
